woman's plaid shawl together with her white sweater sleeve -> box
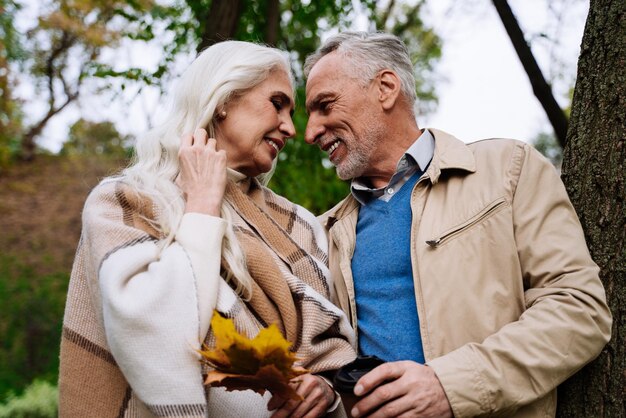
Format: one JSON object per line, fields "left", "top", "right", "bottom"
{"left": 59, "top": 179, "right": 355, "bottom": 418}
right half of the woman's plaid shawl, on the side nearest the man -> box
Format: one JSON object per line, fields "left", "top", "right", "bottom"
{"left": 220, "top": 182, "right": 354, "bottom": 372}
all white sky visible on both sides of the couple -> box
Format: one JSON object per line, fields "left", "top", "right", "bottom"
{"left": 17, "top": 0, "right": 588, "bottom": 151}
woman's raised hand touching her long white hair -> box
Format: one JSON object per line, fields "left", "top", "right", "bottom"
{"left": 176, "top": 129, "right": 226, "bottom": 216}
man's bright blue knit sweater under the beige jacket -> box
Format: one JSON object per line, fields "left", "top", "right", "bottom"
{"left": 352, "top": 173, "right": 424, "bottom": 363}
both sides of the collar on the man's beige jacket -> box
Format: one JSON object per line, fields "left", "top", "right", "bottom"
{"left": 321, "top": 128, "right": 476, "bottom": 230}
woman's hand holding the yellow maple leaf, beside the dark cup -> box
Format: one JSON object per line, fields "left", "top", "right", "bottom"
{"left": 267, "top": 374, "right": 335, "bottom": 418}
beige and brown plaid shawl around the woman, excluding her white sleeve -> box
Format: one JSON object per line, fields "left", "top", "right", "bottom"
{"left": 59, "top": 180, "right": 355, "bottom": 417}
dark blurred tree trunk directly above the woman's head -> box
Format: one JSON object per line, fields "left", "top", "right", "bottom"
{"left": 197, "top": 0, "right": 243, "bottom": 53}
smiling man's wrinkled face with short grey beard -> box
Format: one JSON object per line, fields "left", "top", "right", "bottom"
{"left": 305, "top": 52, "right": 384, "bottom": 180}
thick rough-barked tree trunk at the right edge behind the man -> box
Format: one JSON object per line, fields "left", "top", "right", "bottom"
{"left": 558, "top": 0, "right": 626, "bottom": 418}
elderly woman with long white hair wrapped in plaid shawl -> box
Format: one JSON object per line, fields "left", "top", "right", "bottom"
{"left": 59, "top": 41, "right": 355, "bottom": 418}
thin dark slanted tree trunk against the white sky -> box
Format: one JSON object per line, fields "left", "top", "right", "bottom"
{"left": 493, "top": 0, "right": 567, "bottom": 147}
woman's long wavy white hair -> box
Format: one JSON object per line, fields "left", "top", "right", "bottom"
{"left": 122, "top": 41, "right": 293, "bottom": 297}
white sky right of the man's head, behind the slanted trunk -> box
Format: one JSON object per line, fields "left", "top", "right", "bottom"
{"left": 418, "top": 0, "right": 588, "bottom": 142}
